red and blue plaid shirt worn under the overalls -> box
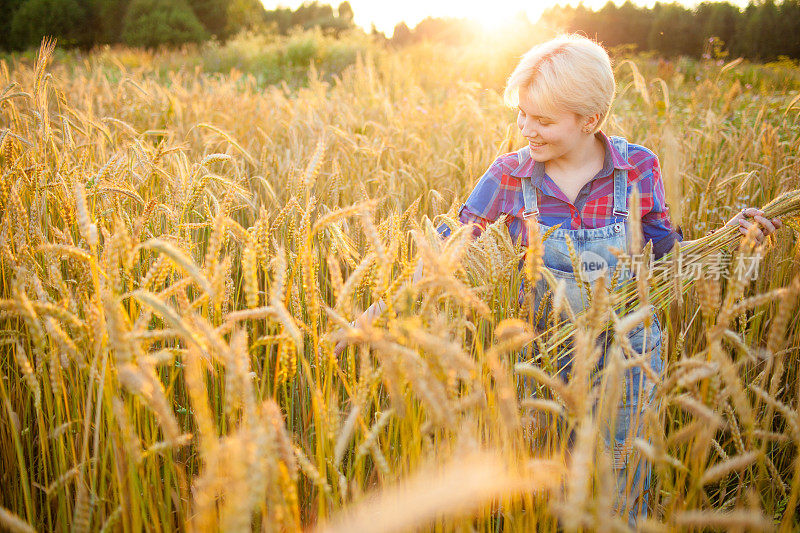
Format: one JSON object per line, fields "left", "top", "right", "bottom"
{"left": 437, "top": 132, "right": 683, "bottom": 259}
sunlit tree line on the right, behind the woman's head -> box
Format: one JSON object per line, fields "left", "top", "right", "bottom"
{"left": 391, "top": 0, "right": 800, "bottom": 60}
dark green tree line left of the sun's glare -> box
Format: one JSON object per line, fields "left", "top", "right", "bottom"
{"left": 0, "top": 0, "right": 353, "bottom": 51}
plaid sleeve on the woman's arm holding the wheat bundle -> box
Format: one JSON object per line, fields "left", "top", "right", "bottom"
{"left": 639, "top": 155, "right": 683, "bottom": 259}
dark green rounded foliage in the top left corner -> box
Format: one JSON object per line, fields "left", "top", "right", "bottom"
{"left": 9, "top": 0, "right": 90, "bottom": 48}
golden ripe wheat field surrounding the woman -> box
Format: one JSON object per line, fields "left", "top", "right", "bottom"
{"left": 0, "top": 35, "right": 800, "bottom": 532}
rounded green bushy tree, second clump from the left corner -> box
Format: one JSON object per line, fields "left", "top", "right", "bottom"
{"left": 122, "top": 0, "right": 207, "bottom": 48}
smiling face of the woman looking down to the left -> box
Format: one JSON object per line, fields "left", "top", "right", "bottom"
{"left": 517, "top": 87, "right": 591, "bottom": 162}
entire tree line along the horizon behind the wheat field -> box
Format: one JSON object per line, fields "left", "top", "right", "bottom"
{"left": 0, "top": 0, "right": 800, "bottom": 61}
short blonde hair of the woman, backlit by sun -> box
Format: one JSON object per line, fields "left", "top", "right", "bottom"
{"left": 503, "top": 34, "right": 615, "bottom": 133}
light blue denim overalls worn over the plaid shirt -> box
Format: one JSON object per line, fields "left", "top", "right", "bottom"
{"left": 522, "top": 137, "right": 662, "bottom": 523}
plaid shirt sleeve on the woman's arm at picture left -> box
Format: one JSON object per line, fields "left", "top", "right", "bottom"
{"left": 436, "top": 158, "right": 506, "bottom": 238}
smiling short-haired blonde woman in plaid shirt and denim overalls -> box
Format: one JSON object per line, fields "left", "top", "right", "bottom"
{"left": 336, "top": 35, "right": 781, "bottom": 522}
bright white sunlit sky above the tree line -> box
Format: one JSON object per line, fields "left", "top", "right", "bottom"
{"left": 262, "top": 0, "right": 747, "bottom": 37}
